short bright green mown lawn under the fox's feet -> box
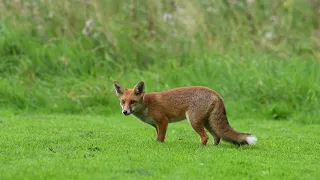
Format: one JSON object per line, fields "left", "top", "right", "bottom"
{"left": 0, "top": 115, "right": 320, "bottom": 180}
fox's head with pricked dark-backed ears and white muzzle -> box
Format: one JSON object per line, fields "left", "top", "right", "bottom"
{"left": 114, "top": 81, "right": 144, "bottom": 116}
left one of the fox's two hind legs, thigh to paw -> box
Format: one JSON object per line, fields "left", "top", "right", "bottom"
{"left": 186, "top": 112, "right": 209, "bottom": 145}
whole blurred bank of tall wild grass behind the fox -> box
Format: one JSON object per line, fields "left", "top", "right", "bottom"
{"left": 0, "top": 0, "right": 320, "bottom": 123}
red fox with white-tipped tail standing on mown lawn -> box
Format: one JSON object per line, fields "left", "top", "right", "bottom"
{"left": 114, "top": 81, "right": 257, "bottom": 145}
